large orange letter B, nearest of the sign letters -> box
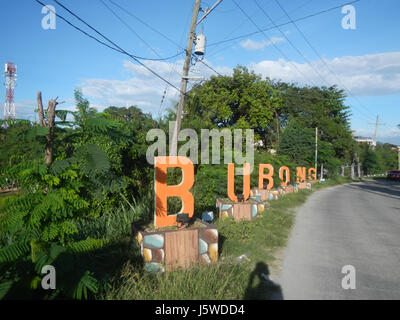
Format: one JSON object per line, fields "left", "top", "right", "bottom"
{"left": 154, "top": 157, "right": 194, "bottom": 228}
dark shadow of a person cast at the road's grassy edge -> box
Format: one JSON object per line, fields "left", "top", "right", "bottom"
{"left": 243, "top": 262, "right": 283, "bottom": 300}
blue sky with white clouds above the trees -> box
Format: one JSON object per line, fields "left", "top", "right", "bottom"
{"left": 0, "top": 0, "right": 400, "bottom": 145}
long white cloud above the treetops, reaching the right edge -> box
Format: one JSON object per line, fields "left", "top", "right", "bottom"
{"left": 249, "top": 52, "right": 400, "bottom": 96}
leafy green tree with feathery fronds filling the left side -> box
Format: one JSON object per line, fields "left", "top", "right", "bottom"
{"left": 0, "top": 89, "right": 130, "bottom": 299}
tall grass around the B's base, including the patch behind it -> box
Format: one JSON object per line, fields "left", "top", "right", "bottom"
{"left": 91, "top": 179, "right": 348, "bottom": 300}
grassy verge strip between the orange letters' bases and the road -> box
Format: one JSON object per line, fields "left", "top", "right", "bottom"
{"left": 96, "top": 178, "right": 351, "bottom": 300}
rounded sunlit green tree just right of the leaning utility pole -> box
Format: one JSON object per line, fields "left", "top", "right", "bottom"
{"left": 183, "top": 66, "right": 280, "bottom": 145}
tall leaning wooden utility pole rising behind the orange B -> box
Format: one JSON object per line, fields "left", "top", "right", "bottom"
{"left": 169, "top": 0, "right": 200, "bottom": 156}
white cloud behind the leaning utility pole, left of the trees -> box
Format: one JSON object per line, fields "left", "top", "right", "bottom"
{"left": 79, "top": 60, "right": 232, "bottom": 116}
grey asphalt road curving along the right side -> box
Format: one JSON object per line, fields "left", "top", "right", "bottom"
{"left": 277, "top": 180, "right": 400, "bottom": 300}
